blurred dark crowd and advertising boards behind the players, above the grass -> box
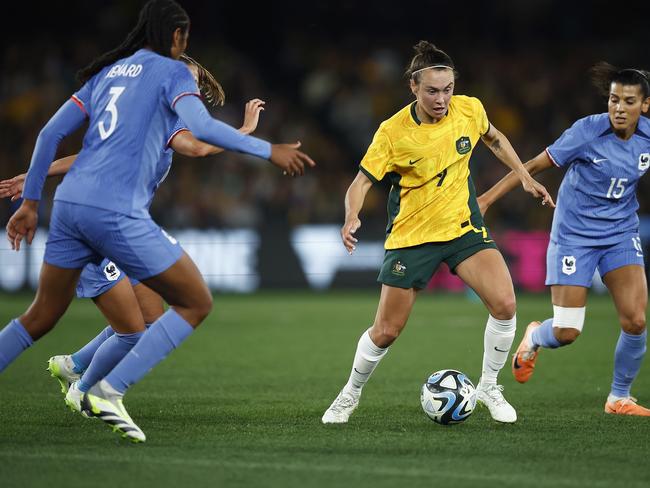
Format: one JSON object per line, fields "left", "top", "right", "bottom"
{"left": 0, "top": 0, "right": 650, "bottom": 291}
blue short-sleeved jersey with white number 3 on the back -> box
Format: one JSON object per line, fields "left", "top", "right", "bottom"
{"left": 55, "top": 49, "right": 199, "bottom": 217}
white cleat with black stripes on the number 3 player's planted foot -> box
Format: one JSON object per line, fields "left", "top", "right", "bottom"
{"left": 81, "top": 380, "right": 147, "bottom": 442}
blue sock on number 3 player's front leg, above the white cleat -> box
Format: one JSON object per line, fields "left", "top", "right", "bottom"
{"left": 104, "top": 308, "right": 194, "bottom": 393}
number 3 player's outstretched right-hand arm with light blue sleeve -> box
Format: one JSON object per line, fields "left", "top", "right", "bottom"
{"left": 174, "top": 96, "right": 316, "bottom": 176}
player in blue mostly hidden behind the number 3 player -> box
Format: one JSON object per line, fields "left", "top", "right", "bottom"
{"left": 0, "top": 55, "right": 265, "bottom": 411}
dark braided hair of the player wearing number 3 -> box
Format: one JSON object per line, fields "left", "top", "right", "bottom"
{"left": 77, "top": 0, "right": 190, "bottom": 83}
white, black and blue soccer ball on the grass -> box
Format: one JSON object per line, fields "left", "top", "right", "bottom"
{"left": 420, "top": 369, "right": 476, "bottom": 425}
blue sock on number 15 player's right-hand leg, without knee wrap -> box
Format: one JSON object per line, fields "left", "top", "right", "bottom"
{"left": 612, "top": 329, "right": 648, "bottom": 397}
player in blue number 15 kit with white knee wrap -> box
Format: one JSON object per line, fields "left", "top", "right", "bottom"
{"left": 479, "top": 63, "right": 650, "bottom": 417}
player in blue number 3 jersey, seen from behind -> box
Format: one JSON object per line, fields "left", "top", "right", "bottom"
{"left": 0, "top": 0, "right": 314, "bottom": 442}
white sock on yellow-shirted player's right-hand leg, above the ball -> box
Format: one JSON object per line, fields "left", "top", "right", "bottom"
{"left": 481, "top": 315, "right": 517, "bottom": 385}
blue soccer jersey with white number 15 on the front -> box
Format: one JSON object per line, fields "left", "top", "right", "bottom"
{"left": 546, "top": 113, "right": 650, "bottom": 246}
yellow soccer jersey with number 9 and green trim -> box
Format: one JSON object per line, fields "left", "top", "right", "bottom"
{"left": 359, "top": 95, "right": 490, "bottom": 249}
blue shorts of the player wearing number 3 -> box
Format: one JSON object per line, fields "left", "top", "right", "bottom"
{"left": 44, "top": 200, "right": 183, "bottom": 280}
